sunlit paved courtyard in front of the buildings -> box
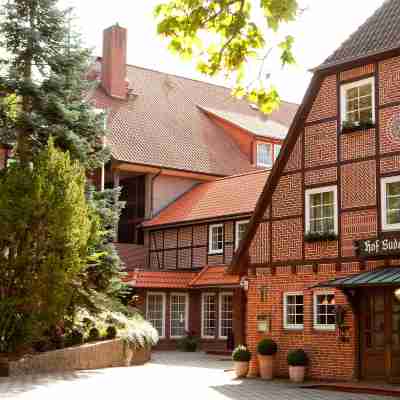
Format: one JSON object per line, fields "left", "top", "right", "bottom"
{"left": 0, "top": 352, "right": 387, "bottom": 400}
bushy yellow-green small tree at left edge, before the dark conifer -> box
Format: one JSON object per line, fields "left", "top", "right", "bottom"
{"left": 0, "top": 140, "right": 93, "bottom": 351}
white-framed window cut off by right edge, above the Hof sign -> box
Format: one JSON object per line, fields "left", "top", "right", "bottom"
{"left": 381, "top": 176, "right": 400, "bottom": 231}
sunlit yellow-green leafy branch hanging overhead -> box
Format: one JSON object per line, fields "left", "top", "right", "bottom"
{"left": 155, "top": 0, "right": 299, "bottom": 113}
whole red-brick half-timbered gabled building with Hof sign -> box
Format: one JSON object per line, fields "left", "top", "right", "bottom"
{"left": 231, "top": 0, "right": 400, "bottom": 381}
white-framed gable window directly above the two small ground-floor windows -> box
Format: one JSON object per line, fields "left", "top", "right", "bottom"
{"left": 305, "top": 186, "right": 338, "bottom": 234}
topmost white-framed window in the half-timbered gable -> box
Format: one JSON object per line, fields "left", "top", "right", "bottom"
{"left": 340, "top": 77, "right": 375, "bottom": 126}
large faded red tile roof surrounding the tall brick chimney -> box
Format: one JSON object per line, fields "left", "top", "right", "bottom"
{"left": 93, "top": 65, "right": 298, "bottom": 176}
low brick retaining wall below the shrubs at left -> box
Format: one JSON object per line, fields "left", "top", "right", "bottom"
{"left": 0, "top": 339, "right": 151, "bottom": 376}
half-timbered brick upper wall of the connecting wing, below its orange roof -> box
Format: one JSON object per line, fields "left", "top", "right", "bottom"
{"left": 145, "top": 215, "right": 250, "bottom": 270}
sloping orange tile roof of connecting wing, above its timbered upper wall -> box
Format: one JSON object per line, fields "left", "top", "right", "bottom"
{"left": 143, "top": 170, "right": 269, "bottom": 227}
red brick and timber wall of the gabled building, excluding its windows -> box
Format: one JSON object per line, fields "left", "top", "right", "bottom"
{"left": 247, "top": 57, "right": 400, "bottom": 379}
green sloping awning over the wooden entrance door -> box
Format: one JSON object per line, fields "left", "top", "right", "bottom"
{"left": 317, "top": 267, "right": 400, "bottom": 288}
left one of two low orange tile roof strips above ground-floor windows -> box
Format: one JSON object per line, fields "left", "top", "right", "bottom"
{"left": 125, "top": 271, "right": 197, "bottom": 289}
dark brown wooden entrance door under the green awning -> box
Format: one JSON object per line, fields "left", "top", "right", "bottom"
{"left": 360, "top": 288, "right": 400, "bottom": 382}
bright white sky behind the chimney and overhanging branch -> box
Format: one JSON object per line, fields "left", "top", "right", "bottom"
{"left": 60, "top": 0, "right": 383, "bottom": 103}
